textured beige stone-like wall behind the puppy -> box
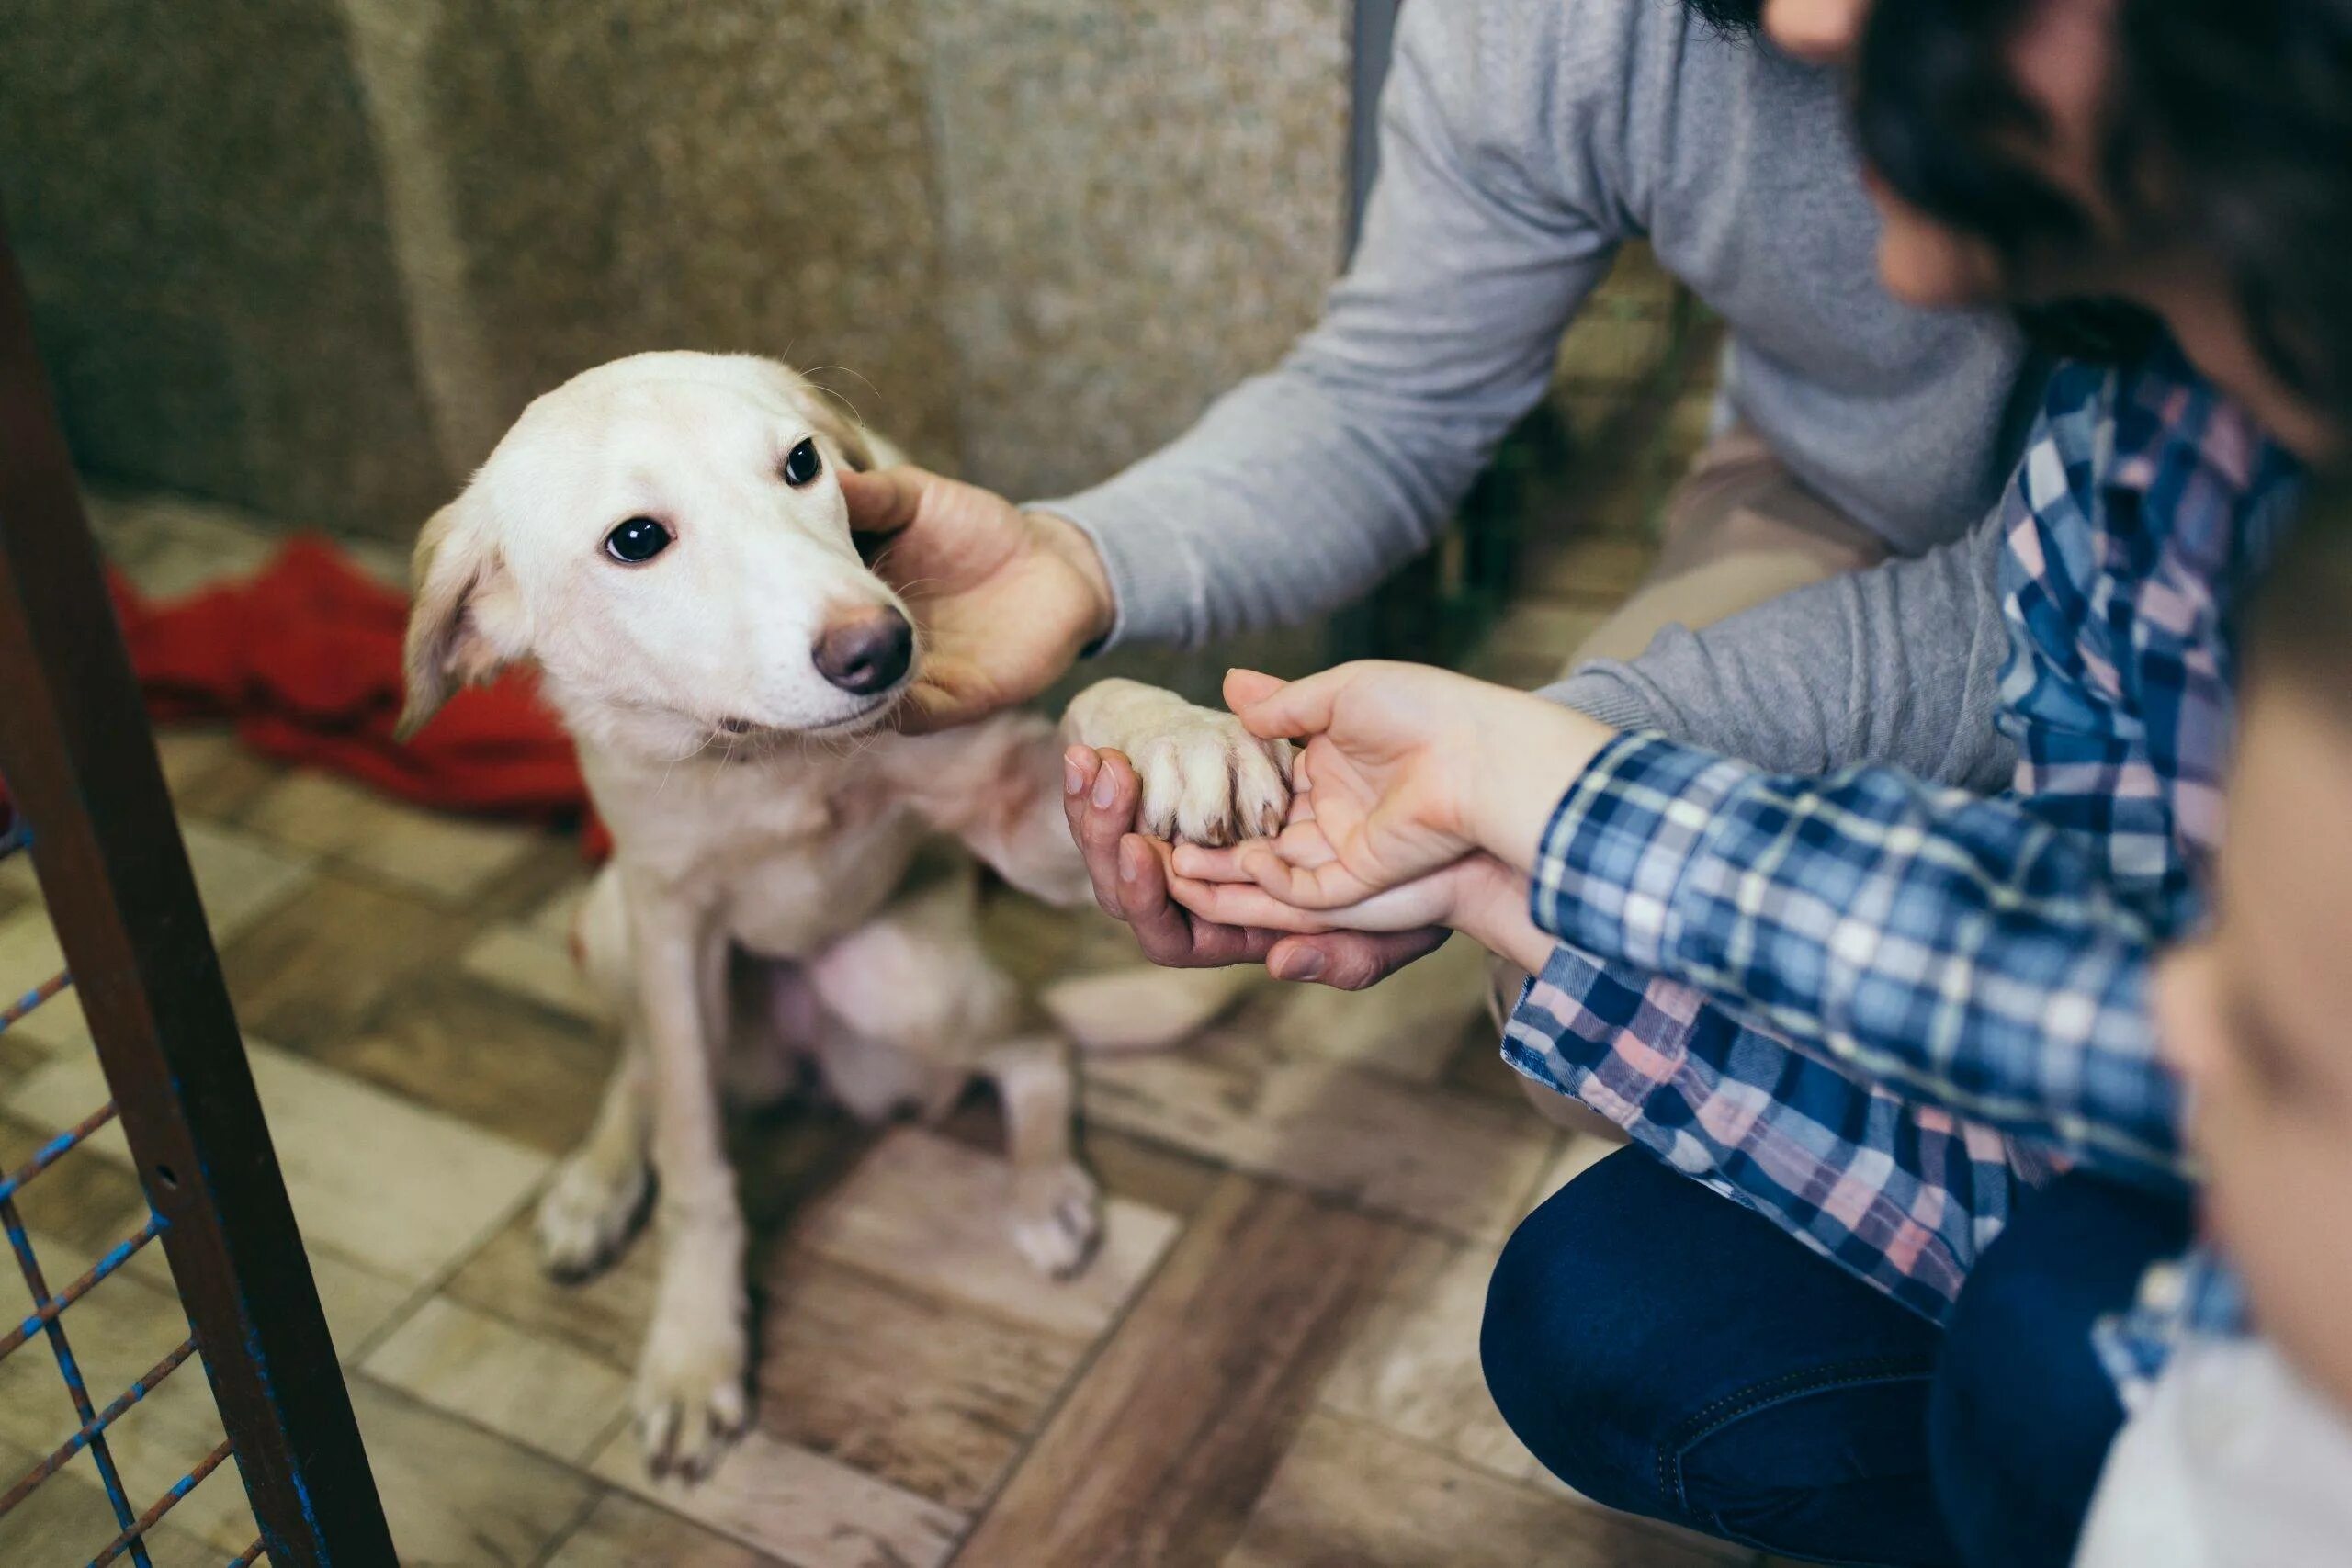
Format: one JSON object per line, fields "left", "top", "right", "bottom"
{"left": 0, "top": 0, "right": 1348, "bottom": 538}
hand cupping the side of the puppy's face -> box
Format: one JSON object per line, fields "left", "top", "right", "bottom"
{"left": 842, "top": 466, "right": 1113, "bottom": 731}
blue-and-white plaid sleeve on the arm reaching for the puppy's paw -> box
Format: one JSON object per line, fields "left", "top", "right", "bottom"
{"left": 1532, "top": 733, "right": 2183, "bottom": 1185}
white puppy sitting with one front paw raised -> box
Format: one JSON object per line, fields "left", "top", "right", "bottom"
{"left": 404, "top": 353, "right": 1289, "bottom": 1474}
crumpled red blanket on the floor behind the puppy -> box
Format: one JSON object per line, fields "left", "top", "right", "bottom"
{"left": 110, "top": 538, "right": 602, "bottom": 851}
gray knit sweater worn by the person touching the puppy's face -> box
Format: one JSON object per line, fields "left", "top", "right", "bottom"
{"left": 1042, "top": 0, "right": 2023, "bottom": 784}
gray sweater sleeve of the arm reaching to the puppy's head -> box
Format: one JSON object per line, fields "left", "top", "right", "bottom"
{"left": 1040, "top": 0, "right": 1616, "bottom": 644}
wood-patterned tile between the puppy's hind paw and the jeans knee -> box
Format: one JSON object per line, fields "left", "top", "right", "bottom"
{"left": 1084, "top": 1030, "right": 1553, "bottom": 1236}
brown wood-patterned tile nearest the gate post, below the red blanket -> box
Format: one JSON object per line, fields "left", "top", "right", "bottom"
{"left": 221, "top": 872, "right": 473, "bottom": 1051}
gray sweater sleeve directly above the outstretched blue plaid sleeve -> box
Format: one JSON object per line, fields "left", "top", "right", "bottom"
{"left": 1543, "top": 513, "right": 2018, "bottom": 795}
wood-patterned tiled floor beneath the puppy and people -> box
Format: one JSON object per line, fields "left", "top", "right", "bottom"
{"left": 0, "top": 355, "right": 1778, "bottom": 1568}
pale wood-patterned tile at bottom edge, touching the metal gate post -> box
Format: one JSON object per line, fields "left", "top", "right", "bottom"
{"left": 350, "top": 1375, "right": 597, "bottom": 1568}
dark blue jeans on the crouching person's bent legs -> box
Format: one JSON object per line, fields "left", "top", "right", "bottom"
{"left": 1479, "top": 1149, "right": 2166, "bottom": 1568}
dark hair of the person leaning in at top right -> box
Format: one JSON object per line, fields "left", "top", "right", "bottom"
{"left": 1856, "top": 0, "right": 2352, "bottom": 423}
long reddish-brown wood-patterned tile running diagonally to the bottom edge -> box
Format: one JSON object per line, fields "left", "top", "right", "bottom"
{"left": 957, "top": 1176, "right": 1408, "bottom": 1568}
